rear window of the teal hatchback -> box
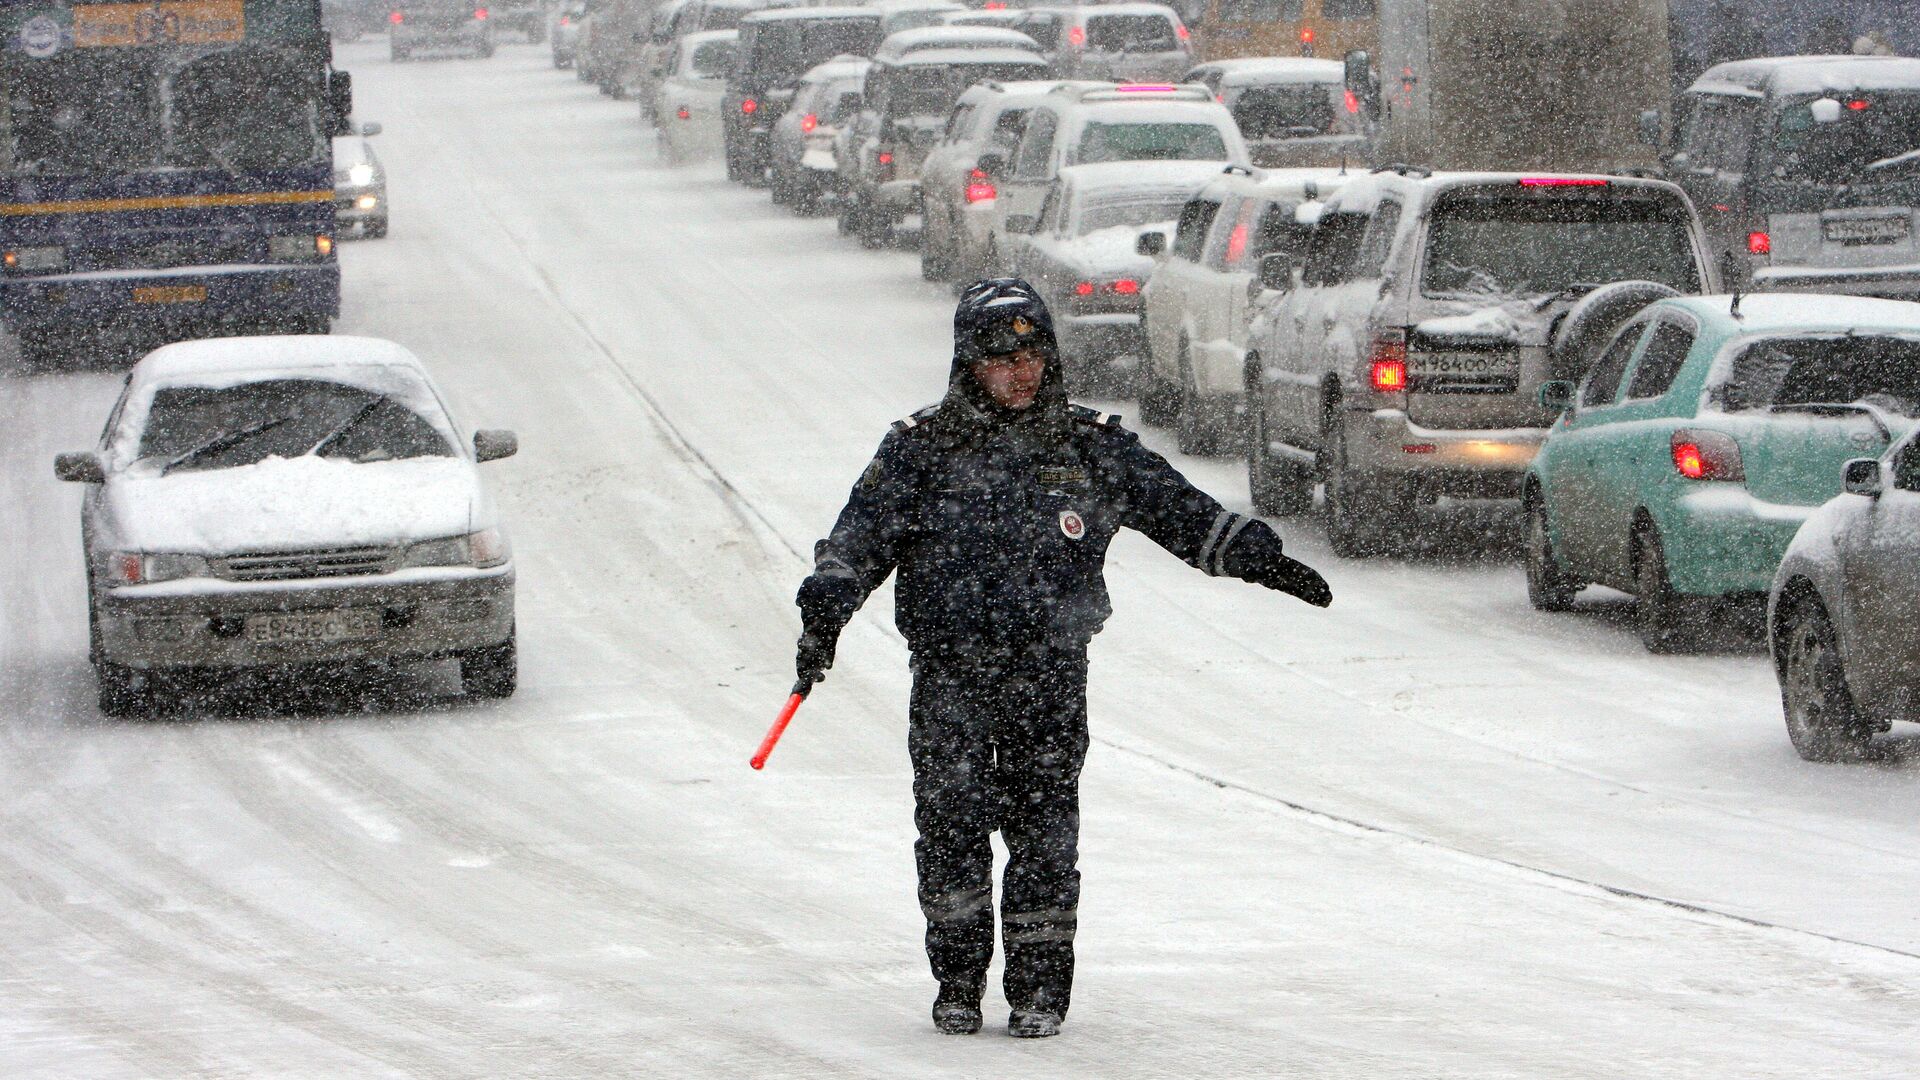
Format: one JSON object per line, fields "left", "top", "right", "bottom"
{"left": 1713, "top": 334, "right": 1920, "bottom": 417}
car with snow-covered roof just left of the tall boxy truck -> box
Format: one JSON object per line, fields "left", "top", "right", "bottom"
{"left": 1181, "top": 56, "right": 1367, "bottom": 169}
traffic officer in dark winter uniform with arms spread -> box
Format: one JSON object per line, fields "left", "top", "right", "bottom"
{"left": 797, "top": 279, "right": 1332, "bottom": 1038}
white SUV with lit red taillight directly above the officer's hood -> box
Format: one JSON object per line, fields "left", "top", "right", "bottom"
{"left": 920, "top": 78, "right": 1060, "bottom": 281}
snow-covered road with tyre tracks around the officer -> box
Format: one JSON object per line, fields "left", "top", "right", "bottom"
{"left": 0, "top": 44, "right": 1920, "bottom": 1078}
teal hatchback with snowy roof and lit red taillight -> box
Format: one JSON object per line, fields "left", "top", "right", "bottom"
{"left": 1523, "top": 294, "right": 1920, "bottom": 651}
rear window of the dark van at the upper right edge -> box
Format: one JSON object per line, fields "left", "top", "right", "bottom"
{"left": 1763, "top": 88, "right": 1920, "bottom": 184}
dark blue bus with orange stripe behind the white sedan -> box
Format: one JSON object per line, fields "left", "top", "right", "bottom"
{"left": 0, "top": 0, "right": 351, "bottom": 367}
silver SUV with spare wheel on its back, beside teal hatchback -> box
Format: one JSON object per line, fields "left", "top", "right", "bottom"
{"left": 1246, "top": 169, "right": 1716, "bottom": 555}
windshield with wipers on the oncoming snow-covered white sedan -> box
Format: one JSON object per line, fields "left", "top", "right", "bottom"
{"left": 140, "top": 379, "right": 453, "bottom": 471}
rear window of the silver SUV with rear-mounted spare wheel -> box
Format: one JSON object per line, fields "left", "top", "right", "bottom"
{"left": 1421, "top": 198, "right": 1699, "bottom": 296}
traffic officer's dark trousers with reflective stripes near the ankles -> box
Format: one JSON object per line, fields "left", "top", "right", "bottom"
{"left": 908, "top": 648, "right": 1087, "bottom": 1015}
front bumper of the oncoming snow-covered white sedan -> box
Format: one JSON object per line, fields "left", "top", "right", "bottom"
{"left": 94, "top": 563, "right": 515, "bottom": 671}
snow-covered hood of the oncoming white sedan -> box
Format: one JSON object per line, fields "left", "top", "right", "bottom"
{"left": 102, "top": 454, "right": 493, "bottom": 555}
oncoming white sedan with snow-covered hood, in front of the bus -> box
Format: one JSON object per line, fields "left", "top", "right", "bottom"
{"left": 54, "top": 336, "right": 518, "bottom": 715}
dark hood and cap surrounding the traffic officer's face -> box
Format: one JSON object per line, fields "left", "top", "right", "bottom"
{"left": 929, "top": 277, "right": 1071, "bottom": 444}
